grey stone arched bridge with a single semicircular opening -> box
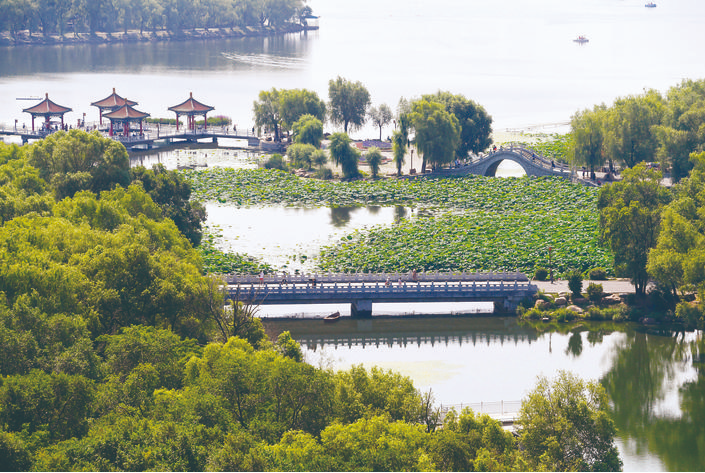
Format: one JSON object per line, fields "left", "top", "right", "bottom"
{"left": 434, "top": 146, "right": 572, "bottom": 178}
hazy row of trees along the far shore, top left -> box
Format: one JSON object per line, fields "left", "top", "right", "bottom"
{"left": 0, "top": 0, "right": 311, "bottom": 43}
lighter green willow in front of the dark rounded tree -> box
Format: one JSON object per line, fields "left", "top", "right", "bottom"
{"left": 410, "top": 99, "right": 460, "bottom": 173}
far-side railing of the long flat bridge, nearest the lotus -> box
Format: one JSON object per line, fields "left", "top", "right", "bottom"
{"left": 225, "top": 271, "right": 529, "bottom": 284}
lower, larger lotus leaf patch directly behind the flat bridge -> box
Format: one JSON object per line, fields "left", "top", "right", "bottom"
{"left": 319, "top": 212, "right": 610, "bottom": 273}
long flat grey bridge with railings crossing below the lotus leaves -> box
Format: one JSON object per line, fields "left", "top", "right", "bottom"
{"left": 227, "top": 273, "right": 537, "bottom": 317}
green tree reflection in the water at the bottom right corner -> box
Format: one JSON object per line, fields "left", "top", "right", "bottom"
{"left": 602, "top": 331, "right": 705, "bottom": 471}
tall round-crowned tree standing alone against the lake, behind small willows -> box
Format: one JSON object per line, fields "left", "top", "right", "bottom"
{"left": 328, "top": 76, "right": 370, "bottom": 134}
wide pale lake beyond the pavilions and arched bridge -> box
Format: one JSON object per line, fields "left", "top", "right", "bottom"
{"left": 0, "top": 0, "right": 705, "bottom": 137}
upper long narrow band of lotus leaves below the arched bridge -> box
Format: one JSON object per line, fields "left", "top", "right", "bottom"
{"left": 181, "top": 168, "right": 598, "bottom": 209}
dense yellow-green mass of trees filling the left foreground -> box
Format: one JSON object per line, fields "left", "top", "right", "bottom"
{"left": 0, "top": 135, "right": 621, "bottom": 471}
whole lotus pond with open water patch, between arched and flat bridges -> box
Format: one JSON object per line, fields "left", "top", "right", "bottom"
{"left": 183, "top": 168, "right": 611, "bottom": 273}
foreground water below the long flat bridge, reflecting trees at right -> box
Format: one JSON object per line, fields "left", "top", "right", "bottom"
{"left": 265, "top": 316, "right": 705, "bottom": 471}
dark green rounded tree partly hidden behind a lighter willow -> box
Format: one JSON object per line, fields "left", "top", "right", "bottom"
{"left": 422, "top": 91, "right": 492, "bottom": 159}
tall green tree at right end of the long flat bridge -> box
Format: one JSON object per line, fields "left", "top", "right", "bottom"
{"left": 597, "top": 164, "right": 670, "bottom": 295}
